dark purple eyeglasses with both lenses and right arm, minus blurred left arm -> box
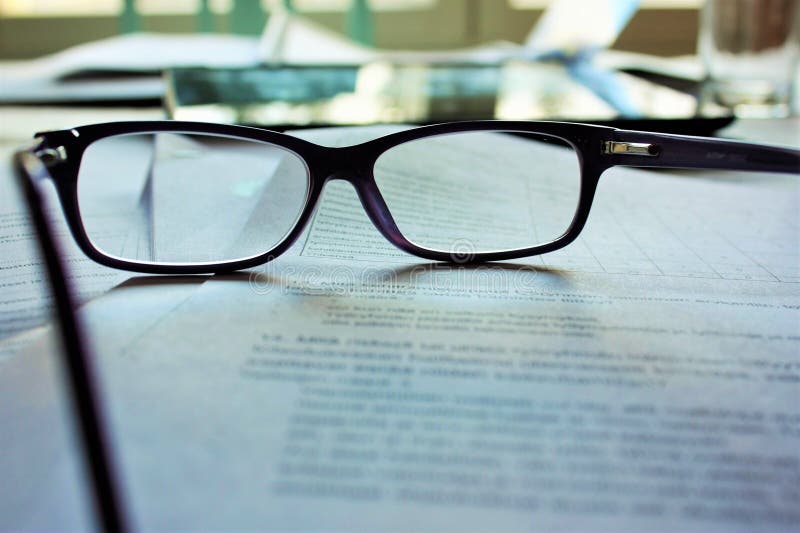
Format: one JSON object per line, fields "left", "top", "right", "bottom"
{"left": 18, "top": 121, "right": 800, "bottom": 274}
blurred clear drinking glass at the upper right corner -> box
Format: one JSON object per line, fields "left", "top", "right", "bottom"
{"left": 698, "top": 0, "right": 800, "bottom": 118}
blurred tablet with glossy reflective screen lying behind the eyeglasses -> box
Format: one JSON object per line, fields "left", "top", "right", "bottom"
{"left": 166, "top": 60, "right": 733, "bottom": 135}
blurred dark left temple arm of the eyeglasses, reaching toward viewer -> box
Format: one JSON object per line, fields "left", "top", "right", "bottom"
{"left": 13, "top": 150, "right": 130, "bottom": 531}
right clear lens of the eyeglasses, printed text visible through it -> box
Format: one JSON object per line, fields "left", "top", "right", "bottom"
{"left": 374, "top": 131, "right": 581, "bottom": 252}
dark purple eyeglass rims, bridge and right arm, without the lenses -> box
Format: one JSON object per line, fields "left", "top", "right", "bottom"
{"left": 17, "top": 120, "right": 800, "bottom": 274}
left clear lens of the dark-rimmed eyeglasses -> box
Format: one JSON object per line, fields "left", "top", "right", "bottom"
{"left": 78, "top": 132, "right": 309, "bottom": 264}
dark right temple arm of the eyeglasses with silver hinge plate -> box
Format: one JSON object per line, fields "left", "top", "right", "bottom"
{"left": 602, "top": 130, "right": 800, "bottom": 174}
